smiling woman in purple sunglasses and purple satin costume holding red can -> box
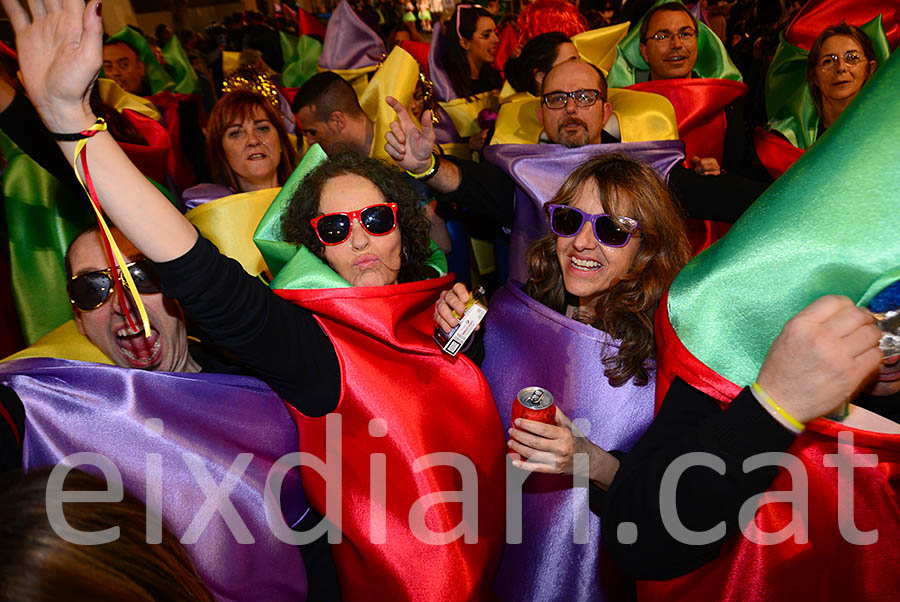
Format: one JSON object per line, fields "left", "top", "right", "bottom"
{"left": 435, "top": 154, "right": 690, "bottom": 600}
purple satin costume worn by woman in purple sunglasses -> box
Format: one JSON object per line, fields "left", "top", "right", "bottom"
{"left": 481, "top": 282, "right": 656, "bottom": 602}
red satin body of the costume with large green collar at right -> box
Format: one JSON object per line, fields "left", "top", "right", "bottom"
{"left": 638, "top": 290, "right": 900, "bottom": 602}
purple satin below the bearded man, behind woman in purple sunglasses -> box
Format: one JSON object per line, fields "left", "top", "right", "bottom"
{"left": 484, "top": 140, "right": 684, "bottom": 282}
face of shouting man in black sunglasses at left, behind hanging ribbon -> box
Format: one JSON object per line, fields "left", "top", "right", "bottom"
{"left": 66, "top": 227, "right": 200, "bottom": 372}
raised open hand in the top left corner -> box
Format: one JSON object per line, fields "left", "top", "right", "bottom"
{"left": 2, "top": 0, "right": 103, "bottom": 132}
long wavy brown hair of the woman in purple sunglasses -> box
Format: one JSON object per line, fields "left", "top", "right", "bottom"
{"left": 525, "top": 153, "right": 691, "bottom": 387}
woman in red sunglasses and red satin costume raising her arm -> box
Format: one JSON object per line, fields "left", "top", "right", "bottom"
{"left": 2, "top": 0, "right": 504, "bottom": 602}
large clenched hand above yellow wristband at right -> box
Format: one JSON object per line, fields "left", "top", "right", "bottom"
{"left": 757, "top": 295, "right": 883, "bottom": 422}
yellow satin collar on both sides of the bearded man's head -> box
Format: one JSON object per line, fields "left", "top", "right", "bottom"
{"left": 491, "top": 88, "right": 678, "bottom": 145}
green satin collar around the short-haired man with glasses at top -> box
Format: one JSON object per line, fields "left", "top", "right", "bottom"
{"left": 606, "top": 0, "right": 742, "bottom": 88}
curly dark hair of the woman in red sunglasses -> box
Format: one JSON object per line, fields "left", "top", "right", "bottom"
{"left": 281, "top": 151, "right": 438, "bottom": 282}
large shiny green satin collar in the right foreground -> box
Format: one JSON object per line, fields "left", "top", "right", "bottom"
{"left": 668, "top": 49, "right": 900, "bottom": 386}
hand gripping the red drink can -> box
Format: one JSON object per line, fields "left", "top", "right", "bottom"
{"left": 508, "top": 407, "right": 619, "bottom": 489}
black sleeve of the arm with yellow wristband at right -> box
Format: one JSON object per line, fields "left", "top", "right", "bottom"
{"left": 602, "top": 379, "right": 795, "bottom": 579}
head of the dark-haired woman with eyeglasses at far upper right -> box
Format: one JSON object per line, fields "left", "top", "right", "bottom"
{"left": 806, "top": 23, "right": 875, "bottom": 134}
